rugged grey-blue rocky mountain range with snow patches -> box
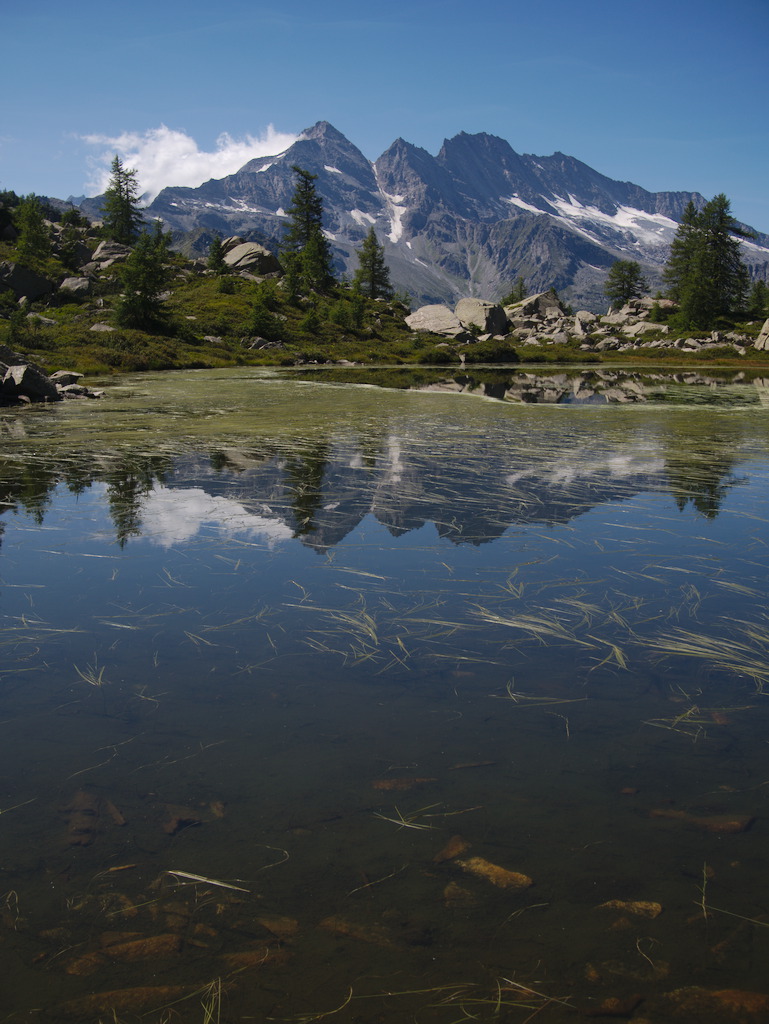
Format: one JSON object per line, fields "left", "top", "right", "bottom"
{"left": 76, "top": 121, "right": 769, "bottom": 310}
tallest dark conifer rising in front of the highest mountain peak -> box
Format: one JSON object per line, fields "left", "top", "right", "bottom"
{"left": 283, "top": 164, "right": 334, "bottom": 293}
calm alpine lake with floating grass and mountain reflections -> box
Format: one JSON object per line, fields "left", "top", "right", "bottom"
{"left": 0, "top": 367, "right": 769, "bottom": 1024}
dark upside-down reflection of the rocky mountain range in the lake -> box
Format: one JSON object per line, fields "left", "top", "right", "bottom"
{"left": 160, "top": 437, "right": 665, "bottom": 549}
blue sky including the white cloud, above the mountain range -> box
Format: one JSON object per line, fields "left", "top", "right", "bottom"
{"left": 0, "top": 0, "right": 769, "bottom": 231}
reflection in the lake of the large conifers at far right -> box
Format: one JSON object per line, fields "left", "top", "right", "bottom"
{"left": 665, "top": 430, "right": 741, "bottom": 519}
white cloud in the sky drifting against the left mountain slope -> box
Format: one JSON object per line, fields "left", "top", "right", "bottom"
{"left": 83, "top": 125, "right": 299, "bottom": 203}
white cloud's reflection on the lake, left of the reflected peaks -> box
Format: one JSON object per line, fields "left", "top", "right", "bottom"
{"left": 141, "top": 487, "right": 294, "bottom": 548}
